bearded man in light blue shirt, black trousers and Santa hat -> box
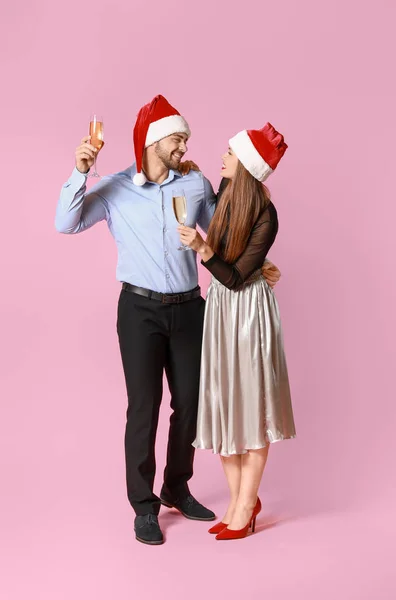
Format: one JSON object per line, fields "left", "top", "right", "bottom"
{"left": 55, "top": 96, "right": 279, "bottom": 544}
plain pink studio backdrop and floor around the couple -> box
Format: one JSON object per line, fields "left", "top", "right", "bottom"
{"left": 0, "top": 0, "right": 396, "bottom": 600}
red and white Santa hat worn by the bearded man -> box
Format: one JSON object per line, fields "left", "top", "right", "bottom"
{"left": 133, "top": 95, "right": 191, "bottom": 186}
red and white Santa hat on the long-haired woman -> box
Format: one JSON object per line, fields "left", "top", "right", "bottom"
{"left": 229, "top": 123, "right": 287, "bottom": 181}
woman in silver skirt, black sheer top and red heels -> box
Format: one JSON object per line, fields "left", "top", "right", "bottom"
{"left": 179, "top": 123, "right": 295, "bottom": 540}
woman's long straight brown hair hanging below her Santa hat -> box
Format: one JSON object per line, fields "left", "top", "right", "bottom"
{"left": 206, "top": 161, "right": 270, "bottom": 264}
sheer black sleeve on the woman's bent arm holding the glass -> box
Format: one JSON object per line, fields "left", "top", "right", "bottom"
{"left": 202, "top": 203, "right": 278, "bottom": 290}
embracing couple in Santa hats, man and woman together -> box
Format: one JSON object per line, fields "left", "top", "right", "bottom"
{"left": 55, "top": 96, "right": 295, "bottom": 545}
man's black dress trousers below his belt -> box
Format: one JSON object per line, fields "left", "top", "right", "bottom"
{"left": 117, "top": 290, "right": 205, "bottom": 515}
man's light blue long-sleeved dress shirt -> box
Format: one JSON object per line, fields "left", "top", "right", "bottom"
{"left": 55, "top": 165, "right": 216, "bottom": 293}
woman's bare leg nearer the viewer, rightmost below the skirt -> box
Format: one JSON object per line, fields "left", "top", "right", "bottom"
{"left": 229, "top": 444, "right": 269, "bottom": 529}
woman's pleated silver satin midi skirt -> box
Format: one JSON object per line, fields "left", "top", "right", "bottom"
{"left": 193, "top": 271, "right": 296, "bottom": 456}
